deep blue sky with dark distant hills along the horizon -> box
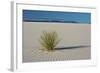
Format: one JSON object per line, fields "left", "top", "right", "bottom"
{"left": 23, "top": 10, "right": 91, "bottom": 24}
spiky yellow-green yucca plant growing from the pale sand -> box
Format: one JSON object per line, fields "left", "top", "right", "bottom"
{"left": 40, "top": 31, "right": 60, "bottom": 51}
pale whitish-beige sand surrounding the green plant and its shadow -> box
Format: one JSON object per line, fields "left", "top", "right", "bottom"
{"left": 23, "top": 22, "right": 91, "bottom": 62}
